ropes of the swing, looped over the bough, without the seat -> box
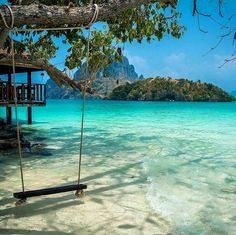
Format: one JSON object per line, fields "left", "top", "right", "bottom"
{"left": 0, "top": 4, "right": 99, "bottom": 196}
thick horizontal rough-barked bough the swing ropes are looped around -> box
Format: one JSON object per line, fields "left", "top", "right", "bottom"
{"left": 0, "top": 0, "right": 176, "bottom": 28}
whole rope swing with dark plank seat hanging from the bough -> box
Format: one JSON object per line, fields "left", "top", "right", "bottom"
{"left": 0, "top": 4, "right": 99, "bottom": 206}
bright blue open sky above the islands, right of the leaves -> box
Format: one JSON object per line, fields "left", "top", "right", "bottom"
{"left": 0, "top": 0, "right": 236, "bottom": 92}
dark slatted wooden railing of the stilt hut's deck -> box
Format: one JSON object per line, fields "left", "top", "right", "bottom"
{"left": 0, "top": 81, "right": 46, "bottom": 103}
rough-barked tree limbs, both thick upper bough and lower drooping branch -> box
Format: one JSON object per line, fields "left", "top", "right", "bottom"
{"left": 0, "top": 0, "right": 176, "bottom": 90}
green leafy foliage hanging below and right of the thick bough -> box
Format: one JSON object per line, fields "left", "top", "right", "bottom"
{"left": 5, "top": 0, "right": 184, "bottom": 78}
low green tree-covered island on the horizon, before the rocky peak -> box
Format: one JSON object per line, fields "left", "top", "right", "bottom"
{"left": 108, "top": 77, "right": 233, "bottom": 102}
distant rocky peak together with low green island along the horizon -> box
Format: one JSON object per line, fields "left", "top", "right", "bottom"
{"left": 47, "top": 57, "right": 234, "bottom": 102}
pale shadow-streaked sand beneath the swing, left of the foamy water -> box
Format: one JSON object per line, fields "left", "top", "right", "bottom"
{"left": 0, "top": 152, "right": 169, "bottom": 235}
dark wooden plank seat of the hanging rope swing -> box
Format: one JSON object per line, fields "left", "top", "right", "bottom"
{"left": 13, "top": 184, "right": 87, "bottom": 199}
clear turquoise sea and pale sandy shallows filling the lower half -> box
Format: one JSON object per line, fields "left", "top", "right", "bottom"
{"left": 0, "top": 101, "right": 236, "bottom": 234}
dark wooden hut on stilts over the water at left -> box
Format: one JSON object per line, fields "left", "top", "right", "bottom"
{"left": 0, "top": 61, "right": 46, "bottom": 124}
